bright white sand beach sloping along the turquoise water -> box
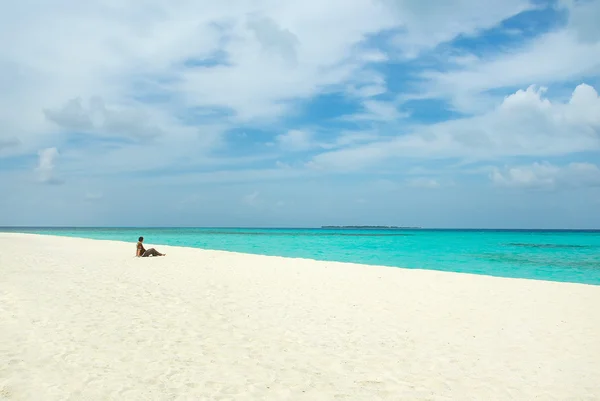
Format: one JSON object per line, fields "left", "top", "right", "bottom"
{"left": 0, "top": 234, "right": 600, "bottom": 401}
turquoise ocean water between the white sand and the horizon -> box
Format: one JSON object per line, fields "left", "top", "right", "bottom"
{"left": 0, "top": 228, "right": 600, "bottom": 285}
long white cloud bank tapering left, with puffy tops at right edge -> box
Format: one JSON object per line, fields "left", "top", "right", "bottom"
{"left": 311, "top": 84, "right": 600, "bottom": 170}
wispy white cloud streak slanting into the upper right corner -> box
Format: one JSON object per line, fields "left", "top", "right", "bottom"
{"left": 415, "top": 1, "right": 600, "bottom": 113}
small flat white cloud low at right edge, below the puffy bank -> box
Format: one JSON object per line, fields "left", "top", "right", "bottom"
{"left": 490, "top": 162, "right": 600, "bottom": 189}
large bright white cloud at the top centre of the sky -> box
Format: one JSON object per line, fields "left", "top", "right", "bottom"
{"left": 163, "top": 0, "right": 404, "bottom": 122}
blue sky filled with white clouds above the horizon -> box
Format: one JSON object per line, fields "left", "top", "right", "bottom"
{"left": 0, "top": 0, "right": 600, "bottom": 229}
